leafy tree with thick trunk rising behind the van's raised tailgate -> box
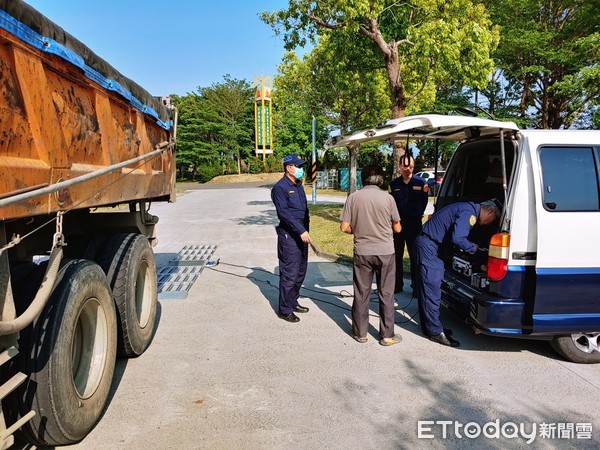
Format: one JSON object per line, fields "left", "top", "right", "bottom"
{"left": 262, "top": 0, "right": 498, "bottom": 173}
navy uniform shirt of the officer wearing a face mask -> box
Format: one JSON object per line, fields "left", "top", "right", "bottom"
{"left": 271, "top": 175, "right": 309, "bottom": 237}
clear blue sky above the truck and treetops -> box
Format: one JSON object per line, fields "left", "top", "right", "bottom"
{"left": 25, "top": 0, "right": 296, "bottom": 96}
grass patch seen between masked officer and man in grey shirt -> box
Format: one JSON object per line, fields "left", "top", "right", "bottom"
{"left": 308, "top": 203, "right": 410, "bottom": 273}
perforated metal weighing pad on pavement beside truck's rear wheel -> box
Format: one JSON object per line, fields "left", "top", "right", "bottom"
{"left": 157, "top": 245, "right": 217, "bottom": 300}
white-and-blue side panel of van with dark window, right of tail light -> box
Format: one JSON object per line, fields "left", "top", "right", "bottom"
{"left": 529, "top": 137, "right": 600, "bottom": 334}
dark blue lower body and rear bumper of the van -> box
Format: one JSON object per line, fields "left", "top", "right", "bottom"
{"left": 450, "top": 266, "right": 600, "bottom": 337}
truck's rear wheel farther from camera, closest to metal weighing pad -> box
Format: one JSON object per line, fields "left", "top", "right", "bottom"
{"left": 97, "top": 233, "right": 158, "bottom": 357}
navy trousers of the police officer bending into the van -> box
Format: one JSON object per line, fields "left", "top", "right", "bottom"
{"left": 413, "top": 236, "right": 444, "bottom": 336}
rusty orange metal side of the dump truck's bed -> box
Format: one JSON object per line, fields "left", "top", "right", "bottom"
{"left": 0, "top": 25, "right": 175, "bottom": 220}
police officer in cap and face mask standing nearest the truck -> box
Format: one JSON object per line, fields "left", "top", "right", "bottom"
{"left": 271, "top": 154, "right": 311, "bottom": 323}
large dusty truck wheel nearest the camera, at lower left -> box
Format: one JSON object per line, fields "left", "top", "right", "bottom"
{"left": 13, "top": 260, "right": 117, "bottom": 446}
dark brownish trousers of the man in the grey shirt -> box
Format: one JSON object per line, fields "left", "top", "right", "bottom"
{"left": 352, "top": 254, "right": 396, "bottom": 339}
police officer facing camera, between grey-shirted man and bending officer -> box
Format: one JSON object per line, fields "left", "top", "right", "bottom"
{"left": 390, "top": 154, "right": 429, "bottom": 293}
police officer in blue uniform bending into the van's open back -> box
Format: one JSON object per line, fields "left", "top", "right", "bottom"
{"left": 414, "top": 199, "right": 502, "bottom": 347}
